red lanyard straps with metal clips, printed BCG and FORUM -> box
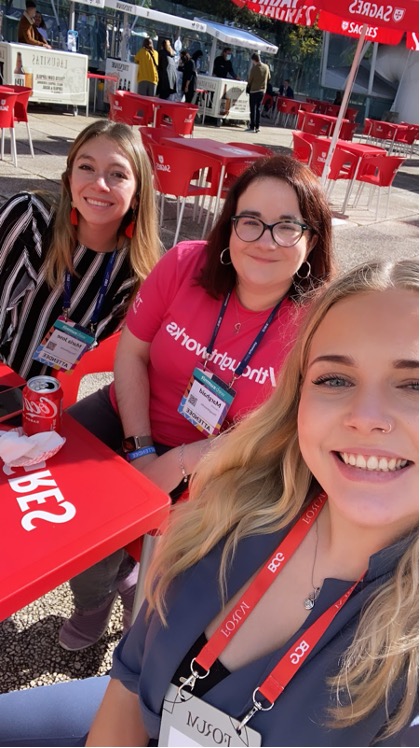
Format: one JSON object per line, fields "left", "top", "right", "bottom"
{"left": 184, "top": 493, "right": 365, "bottom": 728}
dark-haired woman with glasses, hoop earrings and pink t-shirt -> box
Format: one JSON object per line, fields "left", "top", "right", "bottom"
{"left": 59, "top": 156, "right": 333, "bottom": 650}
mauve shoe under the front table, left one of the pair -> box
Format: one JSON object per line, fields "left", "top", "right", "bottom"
{"left": 58, "top": 593, "right": 117, "bottom": 652}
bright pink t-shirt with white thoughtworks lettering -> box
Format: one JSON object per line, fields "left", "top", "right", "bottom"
{"left": 116, "top": 241, "right": 300, "bottom": 447}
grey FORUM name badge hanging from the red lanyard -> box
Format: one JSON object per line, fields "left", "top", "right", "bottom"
{"left": 158, "top": 684, "right": 261, "bottom": 748}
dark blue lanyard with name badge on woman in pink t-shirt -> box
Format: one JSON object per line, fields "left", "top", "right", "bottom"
{"left": 178, "top": 291, "right": 283, "bottom": 436}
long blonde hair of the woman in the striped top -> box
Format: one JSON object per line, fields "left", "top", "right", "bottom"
{"left": 46, "top": 120, "right": 161, "bottom": 293}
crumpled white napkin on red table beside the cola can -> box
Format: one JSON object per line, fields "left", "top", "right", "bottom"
{"left": 0, "top": 427, "right": 66, "bottom": 467}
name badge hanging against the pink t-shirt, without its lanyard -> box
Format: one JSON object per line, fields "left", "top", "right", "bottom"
{"left": 178, "top": 368, "right": 236, "bottom": 436}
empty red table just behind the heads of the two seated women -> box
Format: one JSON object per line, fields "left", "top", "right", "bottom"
{"left": 162, "top": 137, "right": 261, "bottom": 226}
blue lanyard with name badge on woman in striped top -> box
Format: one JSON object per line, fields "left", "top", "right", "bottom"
{"left": 33, "top": 250, "right": 117, "bottom": 371}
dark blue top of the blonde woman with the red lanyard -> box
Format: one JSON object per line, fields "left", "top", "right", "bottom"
{"left": 111, "top": 530, "right": 416, "bottom": 747}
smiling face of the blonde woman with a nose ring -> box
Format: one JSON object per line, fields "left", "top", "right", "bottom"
{"left": 298, "top": 289, "right": 418, "bottom": 542}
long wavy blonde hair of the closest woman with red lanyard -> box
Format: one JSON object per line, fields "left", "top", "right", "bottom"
{"left": 146, "top": 260, "right": 419, "bottom": 736}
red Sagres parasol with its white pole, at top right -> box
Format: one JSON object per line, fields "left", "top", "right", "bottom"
{"left": 232, "top": 0, "right": 419, "bottom": 182}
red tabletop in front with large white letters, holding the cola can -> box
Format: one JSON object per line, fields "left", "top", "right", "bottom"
{"left": 0, "top": 414, "right": 170, "bottom": 620}
